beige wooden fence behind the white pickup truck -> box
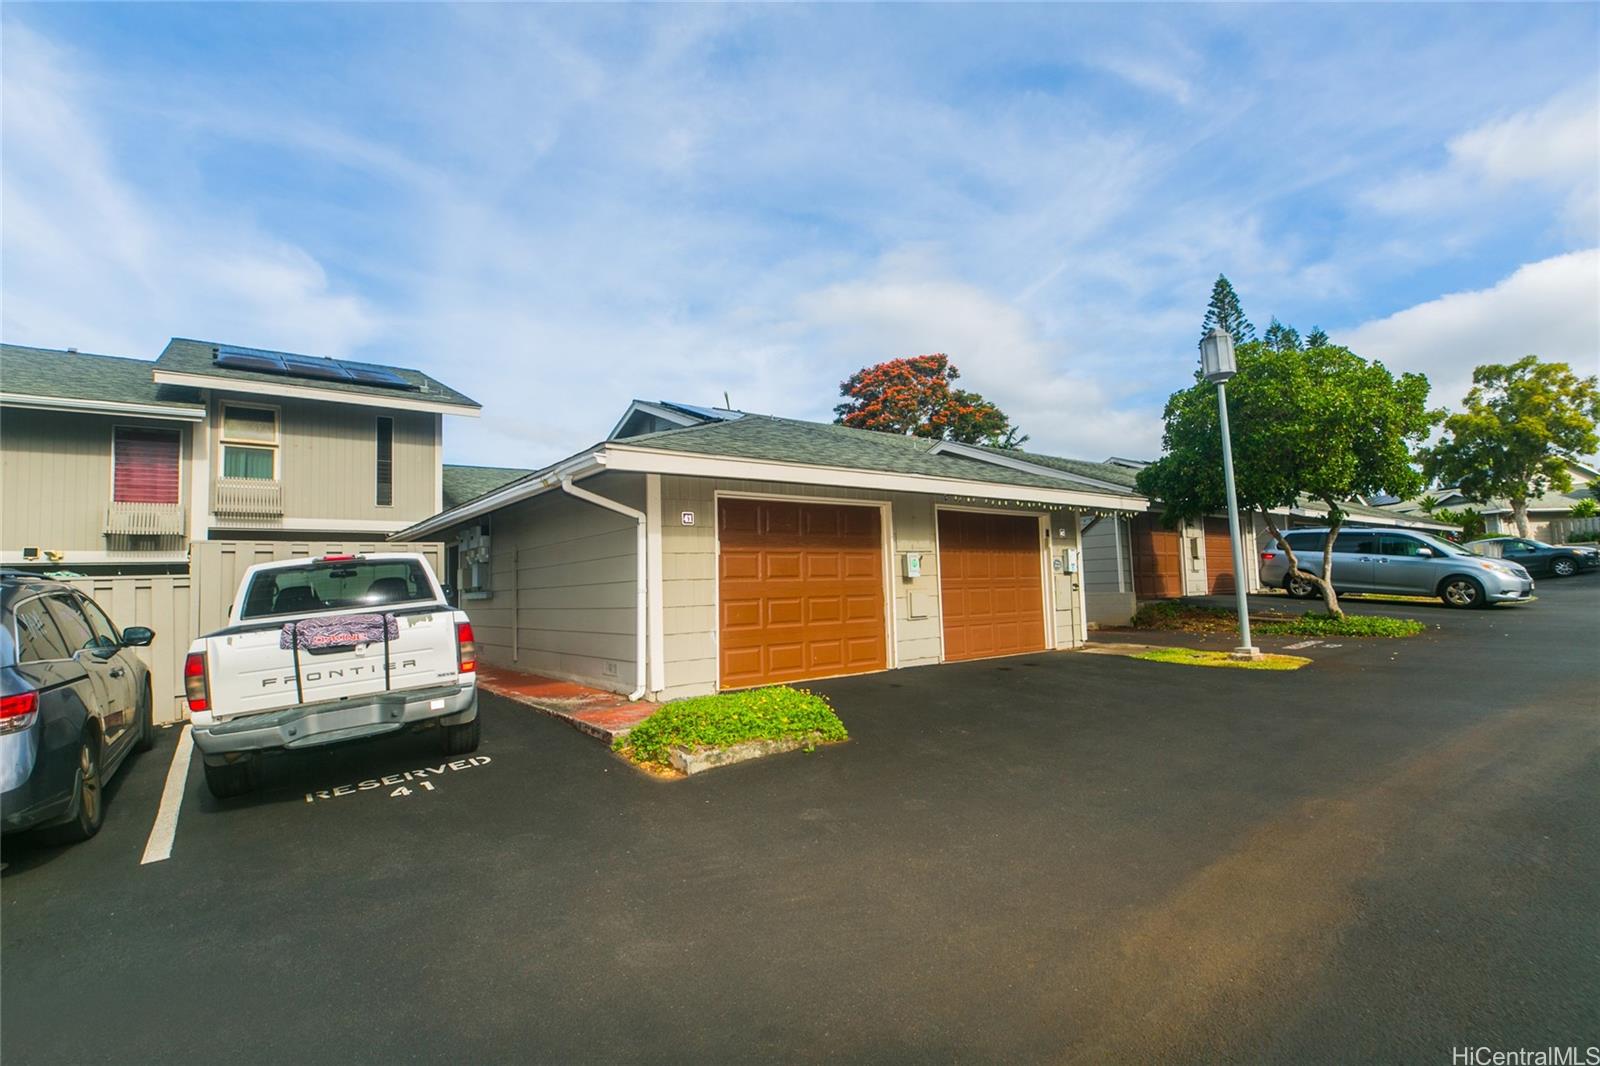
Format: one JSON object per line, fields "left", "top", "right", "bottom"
{"left": 70, "top": 541, "right": 443, "bottom": 723}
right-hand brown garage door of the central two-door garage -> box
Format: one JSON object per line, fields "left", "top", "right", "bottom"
{"left": 939, "top": 511, "right": 1045, "bottom": 659}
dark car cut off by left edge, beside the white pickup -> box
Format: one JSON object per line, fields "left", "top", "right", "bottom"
{"left": 0, "top": 571, "right": 155, "bottom": 840}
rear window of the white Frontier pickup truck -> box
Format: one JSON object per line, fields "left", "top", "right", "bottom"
{"left": 238, "top": 559, "right": 437, "bottom": 621}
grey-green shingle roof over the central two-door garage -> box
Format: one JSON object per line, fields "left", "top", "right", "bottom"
{"left": 611, "top": 415, "right": 1134, "bottom": 495}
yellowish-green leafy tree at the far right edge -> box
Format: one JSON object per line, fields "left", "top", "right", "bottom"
{"left": 1424, "top": 355, "right": 1600, "bottom": 536}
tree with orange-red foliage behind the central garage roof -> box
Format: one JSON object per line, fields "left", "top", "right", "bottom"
{"left": 834, "top": 354, "right": 1027, "bottom": 448}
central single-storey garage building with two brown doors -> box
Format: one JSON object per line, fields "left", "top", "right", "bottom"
{"left": 394, "top": 402, "right": 1146, "bottom": 699}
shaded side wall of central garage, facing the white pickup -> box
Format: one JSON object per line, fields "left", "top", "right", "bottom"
{"left": 461, "top": 474, "right": 645, "bottom": 693}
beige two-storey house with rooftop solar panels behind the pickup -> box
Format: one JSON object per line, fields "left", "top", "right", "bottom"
{"left": 0, "top": 339, "right": 478, "bottom": 571}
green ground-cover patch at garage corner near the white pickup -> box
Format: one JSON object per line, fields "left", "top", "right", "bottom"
{"left": 611, "top": 685, "right": 850, "bottom": 767}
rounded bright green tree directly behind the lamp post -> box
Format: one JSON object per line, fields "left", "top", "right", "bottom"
{"left": 1138, "top": 341, "right": 1435, "bottom": 605}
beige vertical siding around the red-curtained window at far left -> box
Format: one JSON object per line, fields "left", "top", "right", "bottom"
{"left": 0, "top": 407, "right": 192, "bottom": 550}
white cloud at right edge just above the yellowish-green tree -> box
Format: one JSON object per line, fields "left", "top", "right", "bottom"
{"left": 1334, "top": 248, "right": 1600, "bottom": 407}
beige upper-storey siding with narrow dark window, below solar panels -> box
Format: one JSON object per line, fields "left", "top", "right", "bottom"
{"left": 211, "top": 395, "right": 440, "bottom": 525}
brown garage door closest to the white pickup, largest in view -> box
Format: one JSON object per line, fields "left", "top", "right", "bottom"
{"left": 717, "top": 499, "right": 888, "bottom": 688}
